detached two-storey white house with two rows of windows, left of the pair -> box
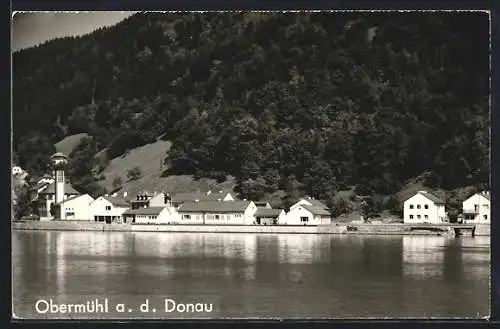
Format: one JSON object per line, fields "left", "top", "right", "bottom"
{"left": 403, "top": 191, "right": 448, "bottom": 224}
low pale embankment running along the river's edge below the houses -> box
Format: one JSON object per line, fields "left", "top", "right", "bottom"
{"left": 12, "top": 220, "right": 490, "bottom": 236}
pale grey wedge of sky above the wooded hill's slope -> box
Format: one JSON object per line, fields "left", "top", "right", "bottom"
{"left": 11, "top": 11, "right": 135, "bottom": 52}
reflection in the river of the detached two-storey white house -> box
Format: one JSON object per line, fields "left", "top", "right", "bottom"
{"left": 403, "top": 236, "right": 449, "bottom": 279}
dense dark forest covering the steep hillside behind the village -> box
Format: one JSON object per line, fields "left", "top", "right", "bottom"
{"left": 13, "top": 12, "right": 490, "bottom": 208}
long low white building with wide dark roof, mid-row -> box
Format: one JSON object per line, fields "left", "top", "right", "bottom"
{"left": 173, "top": 200, "right": 257, "bottom": 225}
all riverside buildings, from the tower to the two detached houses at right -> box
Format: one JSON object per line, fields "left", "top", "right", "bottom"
{"left": 25, "top": 153, "right": 490, "bottom": 225}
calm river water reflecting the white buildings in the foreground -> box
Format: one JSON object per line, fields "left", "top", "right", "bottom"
{"left": 12, "top": 231, "right": 490, "bottom": 319}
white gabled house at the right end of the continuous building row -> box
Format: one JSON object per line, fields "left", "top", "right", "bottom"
{"left": 285, "top": 198, "right": 332, "bottom": 225}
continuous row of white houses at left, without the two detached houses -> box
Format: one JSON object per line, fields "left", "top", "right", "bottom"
{"left": 27, "top": 182, "right": 331, "bottom": 225}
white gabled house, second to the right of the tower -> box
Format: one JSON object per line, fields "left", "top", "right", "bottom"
{"left": 90, "top": 196, "right": 130, "bottom": 223}
